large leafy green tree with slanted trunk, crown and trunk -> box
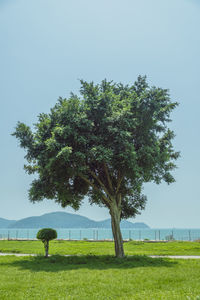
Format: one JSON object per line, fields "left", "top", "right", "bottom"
{"left": 13, "top": 76, "right": 179, "bottom": 257}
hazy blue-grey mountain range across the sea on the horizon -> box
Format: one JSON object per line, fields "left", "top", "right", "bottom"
{"left": 0, "top": 212, "right": 149, "bottom": 229}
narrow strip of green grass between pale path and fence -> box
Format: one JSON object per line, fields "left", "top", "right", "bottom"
{"left": 0, "top": 240, "right": 200, "bottom": 255}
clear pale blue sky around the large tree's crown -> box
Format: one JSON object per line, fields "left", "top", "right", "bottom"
{"left": 0, "top": 0, "right": 200, "bottom": 228}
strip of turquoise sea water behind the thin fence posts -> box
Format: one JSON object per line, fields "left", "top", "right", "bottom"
{"left": 0, "top": 228, "right": 200, "bottom": 241}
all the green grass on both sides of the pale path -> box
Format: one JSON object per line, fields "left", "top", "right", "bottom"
{"left": 0, "top": 241, "right": 200, "bottom": 300}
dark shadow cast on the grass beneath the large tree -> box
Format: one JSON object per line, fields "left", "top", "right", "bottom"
{"left": 2, "top": 255, "right": 177, "bottom": 272}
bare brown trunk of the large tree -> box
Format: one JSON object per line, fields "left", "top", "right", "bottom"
{"left": 110, "top": 203, "right": 124, "bottom": 258}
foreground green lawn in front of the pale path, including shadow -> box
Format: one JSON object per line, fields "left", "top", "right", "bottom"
{"left": 0, "top": 255, "right": 200, "bottom": 300}
